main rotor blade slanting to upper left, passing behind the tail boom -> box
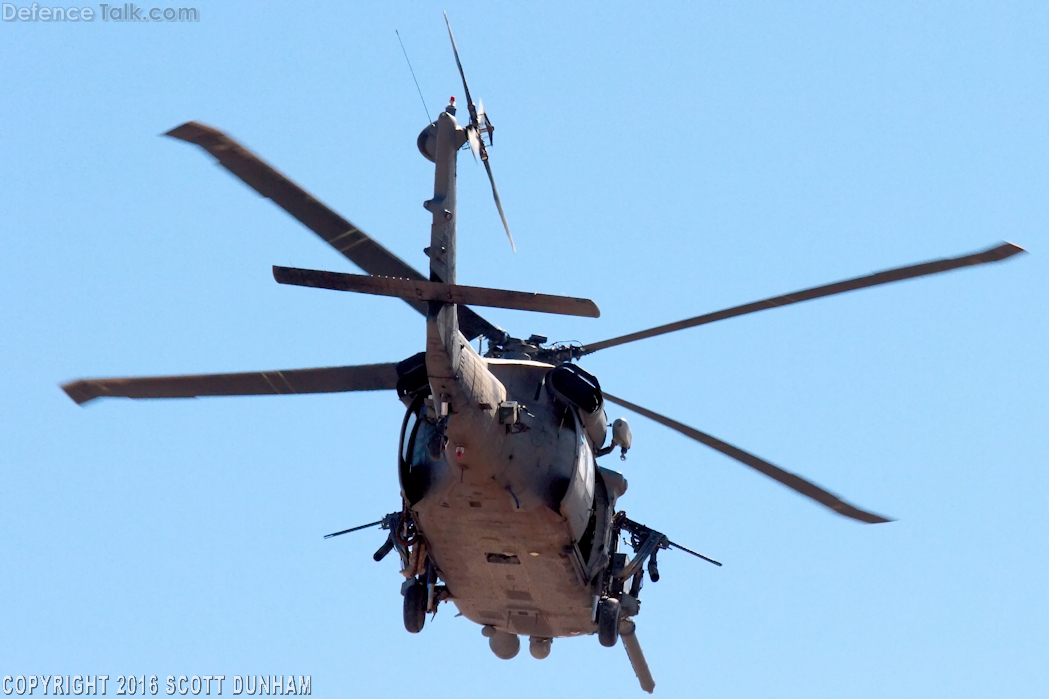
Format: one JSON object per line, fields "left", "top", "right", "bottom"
{"left": 165, "top": 122, "right": 505, "bottom": 340}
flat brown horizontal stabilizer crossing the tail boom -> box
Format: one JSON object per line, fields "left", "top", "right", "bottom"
{"left": 273, "top": 267, "right": 601, "bottom": 318}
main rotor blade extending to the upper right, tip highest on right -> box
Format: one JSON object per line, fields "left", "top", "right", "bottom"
{"left": 580, "top": 242, "right": 1026, "bottom": 356}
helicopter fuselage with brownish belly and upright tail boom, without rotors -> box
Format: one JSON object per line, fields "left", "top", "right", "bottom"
{"left": 402, "top": 106, "right": 625, "bottom": 638}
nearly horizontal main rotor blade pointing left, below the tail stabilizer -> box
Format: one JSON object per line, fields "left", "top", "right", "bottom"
{"left": 62, "top": 363, "right": 398, "bottom": 405}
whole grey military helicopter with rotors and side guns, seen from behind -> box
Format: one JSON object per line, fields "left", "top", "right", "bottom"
{"left": 63, "top": 18, "right": 1023, "bottom": 692}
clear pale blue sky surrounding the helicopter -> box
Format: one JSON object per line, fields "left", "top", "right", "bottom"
{"left": 0, "top": 1, "right": 1049, "bottom": 699}
